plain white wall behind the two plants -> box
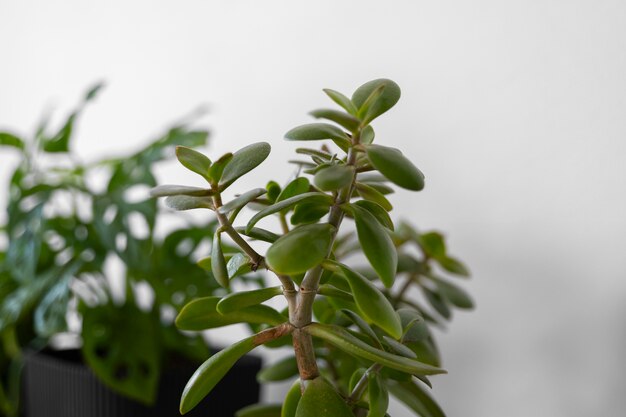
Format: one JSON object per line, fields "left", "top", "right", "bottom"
{"left": 0, "top": 0, "right": 626, "bottom": 417}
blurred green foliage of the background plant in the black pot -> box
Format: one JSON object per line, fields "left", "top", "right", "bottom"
{"left": 0, "top": 85, "right": 227, "bottom": 416}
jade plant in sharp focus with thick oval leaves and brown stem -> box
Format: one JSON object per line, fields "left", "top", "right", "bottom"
{"left": 152, "top": 79, "right": 473, "bottom": 417}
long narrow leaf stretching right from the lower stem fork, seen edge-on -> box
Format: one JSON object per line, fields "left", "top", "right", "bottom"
{"left": 304, "top": 323, "right": 446, "bottom": 375}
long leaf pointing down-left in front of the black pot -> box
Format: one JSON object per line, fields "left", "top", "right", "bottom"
{"left": 180, "top": 336, "right": 257, "bottom": 414}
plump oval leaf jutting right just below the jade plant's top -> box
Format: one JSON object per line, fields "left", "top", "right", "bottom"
{"left": 366, "top": 145, "right": 424, "bottom": 191}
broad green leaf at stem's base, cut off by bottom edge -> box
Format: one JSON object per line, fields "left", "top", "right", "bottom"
{"left": 295, "top": 377, "right": 354, "bottom": 417}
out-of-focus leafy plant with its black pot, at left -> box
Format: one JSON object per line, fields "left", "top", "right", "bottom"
{"left": 0, "top": 85, "right": 260, "bottom": 417}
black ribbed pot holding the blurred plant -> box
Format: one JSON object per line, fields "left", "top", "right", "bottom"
{"left": 23, "top": 350, "right": 261, "bottom": 417}
